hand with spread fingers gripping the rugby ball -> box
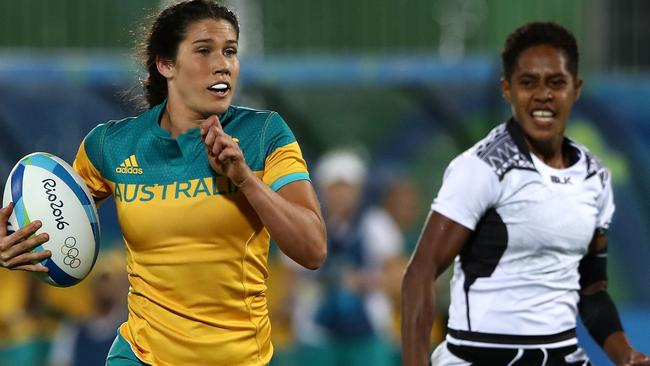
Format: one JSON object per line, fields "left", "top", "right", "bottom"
{"left": 0, "top": 203, "right": 52, "bottom": 272}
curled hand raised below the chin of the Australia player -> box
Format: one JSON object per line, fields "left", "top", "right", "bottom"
{"left": 201, "top": 116, "right": 253, "bottom": 186}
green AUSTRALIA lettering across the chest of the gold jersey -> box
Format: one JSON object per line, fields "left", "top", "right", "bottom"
{"left": 113, "top": 176, "right": 239, "bottom": 202}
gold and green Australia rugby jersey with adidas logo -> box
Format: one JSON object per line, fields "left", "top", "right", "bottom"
{"left": 74, "top": 104, "right": 309, "bottom": 366}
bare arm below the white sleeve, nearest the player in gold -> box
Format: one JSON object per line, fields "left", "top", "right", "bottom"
{"left": 402, "top": 211, "right": 472, "bottom": 366}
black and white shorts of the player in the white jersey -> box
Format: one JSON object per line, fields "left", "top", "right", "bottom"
{"left": 431, "top": 341, "right": 591, "bottom": 366}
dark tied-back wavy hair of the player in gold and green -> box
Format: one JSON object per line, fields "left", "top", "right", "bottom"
{"left": 136, "top": 0, "right": 239, "bottom": 107}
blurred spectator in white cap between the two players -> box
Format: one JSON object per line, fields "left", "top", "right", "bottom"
{"left": 294, "top": 149, "right": 394, "bottom": 365}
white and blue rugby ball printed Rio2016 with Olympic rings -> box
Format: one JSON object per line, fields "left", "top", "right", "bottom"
{"left": 3, "top": 152, "right": 99, "bottom": 287}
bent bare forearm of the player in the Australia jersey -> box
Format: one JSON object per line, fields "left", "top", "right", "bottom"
{"left": 240, "top": 177, "right": 327, "bottom": 269}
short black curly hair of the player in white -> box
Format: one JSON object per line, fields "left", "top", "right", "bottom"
{"left": 501, "top": 22, "right": 579, "bottom": 80}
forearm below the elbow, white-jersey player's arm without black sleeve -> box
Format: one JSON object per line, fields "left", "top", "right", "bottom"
{"left": 402, "top": 269, "right": 435, "bottom": 366}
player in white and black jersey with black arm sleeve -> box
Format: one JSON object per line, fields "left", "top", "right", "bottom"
{"left": 402, "top": 22, "right": 650, "bottom": 366}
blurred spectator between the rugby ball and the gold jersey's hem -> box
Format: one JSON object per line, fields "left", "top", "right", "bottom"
{"left": 48, "top": 249, "right": 129, "bottom": 366}
